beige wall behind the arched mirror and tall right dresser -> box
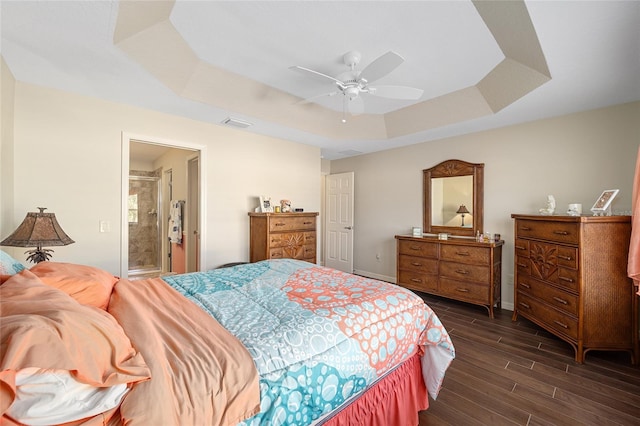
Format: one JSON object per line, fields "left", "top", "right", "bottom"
{"left": 331, "top": 102, "right": 640, "bottom": 309}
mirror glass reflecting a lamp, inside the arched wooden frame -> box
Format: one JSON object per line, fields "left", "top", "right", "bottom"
{"left": 431, "top": 175, "right": 473, "bottom": 228}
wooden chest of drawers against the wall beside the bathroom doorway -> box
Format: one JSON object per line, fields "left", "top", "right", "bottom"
{"left": 249, "top": 213, "right": 318, "bottom": 263}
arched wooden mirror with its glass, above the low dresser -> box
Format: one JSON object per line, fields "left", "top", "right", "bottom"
{"left": 422, "top": 160, "right": 484, "bottom": 237}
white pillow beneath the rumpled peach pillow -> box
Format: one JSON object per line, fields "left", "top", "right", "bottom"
{"left": 6, "top": 368, "right": 129, "bottom": 426}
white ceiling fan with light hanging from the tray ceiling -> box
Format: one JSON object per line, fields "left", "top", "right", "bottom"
{"left": 290, "top": 50, "right": 424, "bottom": 122}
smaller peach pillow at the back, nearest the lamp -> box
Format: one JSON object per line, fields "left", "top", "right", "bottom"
{"left": 30, "top": 262, "right": 118, "bottom": 310}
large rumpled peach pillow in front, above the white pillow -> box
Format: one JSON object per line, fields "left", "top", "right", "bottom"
{"left": 0, "top": 270, "right": 150, "bottom": 424}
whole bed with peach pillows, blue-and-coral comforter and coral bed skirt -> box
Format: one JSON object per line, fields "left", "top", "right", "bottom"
{"left": 0, "top": 255, "right": 455, "bottom": 426}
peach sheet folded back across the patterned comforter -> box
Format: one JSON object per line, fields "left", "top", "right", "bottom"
{"left": 108, "top": 278, "right": 260, "bottom": 425}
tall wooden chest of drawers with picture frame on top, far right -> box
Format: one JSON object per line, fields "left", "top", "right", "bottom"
{"left": 511, "top": 214, "right": 638, "bottom": 363}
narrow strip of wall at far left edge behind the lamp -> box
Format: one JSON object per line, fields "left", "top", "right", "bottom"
{"left": 0, "top": 57, "right": 16, "bottom": 243}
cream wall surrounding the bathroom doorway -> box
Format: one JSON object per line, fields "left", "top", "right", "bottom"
{"left": 8, "top": 82, "right": 321, "bottom": 274}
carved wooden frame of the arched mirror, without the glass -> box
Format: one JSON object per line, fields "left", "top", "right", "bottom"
{"left": 422, "top": 160, "right": 484, "bottom": 237}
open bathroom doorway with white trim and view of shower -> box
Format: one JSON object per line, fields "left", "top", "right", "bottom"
{"left": 120, "top": 133, "right": 206, "bottom": 278}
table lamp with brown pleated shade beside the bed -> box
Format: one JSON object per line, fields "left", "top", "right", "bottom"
{"left": 0, "top": 207, "right": 75, "bottom": 263}
